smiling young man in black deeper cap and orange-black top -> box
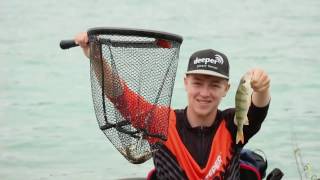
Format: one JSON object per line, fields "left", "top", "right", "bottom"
{"left": 75, "top": 33, "right": 270, "bottom": 179}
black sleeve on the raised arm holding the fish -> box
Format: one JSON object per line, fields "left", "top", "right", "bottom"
{"left": 243, "top": 103, "right": 269, "bottom": 143}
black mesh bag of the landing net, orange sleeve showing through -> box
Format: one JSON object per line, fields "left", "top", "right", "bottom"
{"left": 89, "top": 29, "right": 181, "bottom": 163}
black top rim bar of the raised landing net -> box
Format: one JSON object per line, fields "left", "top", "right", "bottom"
{"left": 87, "top": 27, "right": 183, "bottom": 43}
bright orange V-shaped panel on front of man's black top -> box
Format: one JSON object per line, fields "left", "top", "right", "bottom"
{"left": 165, "top": 113, "right": 232, "bottom": 180}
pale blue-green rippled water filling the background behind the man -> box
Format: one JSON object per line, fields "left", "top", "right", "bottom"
{"left": 0, "top": 0, "right": 320, "bottom": 180}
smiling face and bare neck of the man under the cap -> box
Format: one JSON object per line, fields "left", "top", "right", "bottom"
{"left": 184, "top": 74, "right": 230, "bottom": 125}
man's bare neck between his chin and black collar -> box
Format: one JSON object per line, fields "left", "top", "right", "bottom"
{"left": 187, "top": 108, "right": 217, "bottom": 128}
